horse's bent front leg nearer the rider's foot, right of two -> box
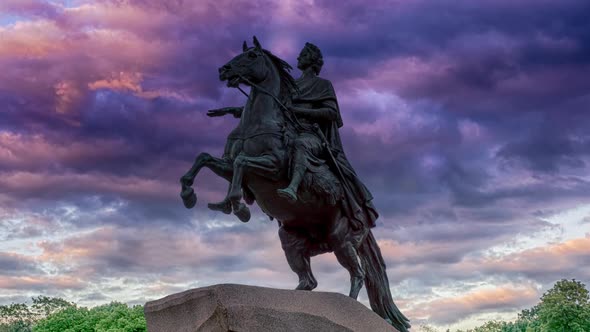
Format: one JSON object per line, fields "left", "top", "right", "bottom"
{"left": 227, "top": 154, "right": 277, "bottom": 222}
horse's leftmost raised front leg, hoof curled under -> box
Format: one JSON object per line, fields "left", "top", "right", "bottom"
{"left": 180, "top": 152, "right": 233, "bottom": 209}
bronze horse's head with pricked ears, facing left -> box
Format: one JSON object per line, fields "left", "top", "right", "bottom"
{"left": 219, "top": 37, "right": 271, "bottom": 87}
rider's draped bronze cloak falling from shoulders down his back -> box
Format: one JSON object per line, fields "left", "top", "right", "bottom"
{"left": 293, "top": 76, "right": 379, "bottom": 229}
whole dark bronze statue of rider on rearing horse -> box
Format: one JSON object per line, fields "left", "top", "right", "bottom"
{"left": 180, "top": 37, "right": 410, "bottom": 332}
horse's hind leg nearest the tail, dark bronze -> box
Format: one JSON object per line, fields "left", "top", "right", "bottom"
{"left": 328, "top": 213, "right": 365, "bottom": 299}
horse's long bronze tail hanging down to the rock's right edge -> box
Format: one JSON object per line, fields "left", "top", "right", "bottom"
{"left": 359, "top": 231, "right": 410, "bottom": 332}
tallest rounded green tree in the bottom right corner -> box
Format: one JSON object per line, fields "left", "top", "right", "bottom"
{"left": 537, "top": 279, "right": 590, "bottom": 332}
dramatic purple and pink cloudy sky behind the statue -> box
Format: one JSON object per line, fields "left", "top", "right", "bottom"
{"left": 0, "top": 0, "right": 590, "bottom": 328}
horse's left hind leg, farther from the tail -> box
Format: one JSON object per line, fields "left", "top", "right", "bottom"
{"left": 279, "top": 226, "right": 318, "bottom": 290}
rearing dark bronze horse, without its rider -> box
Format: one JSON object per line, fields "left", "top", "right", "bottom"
{"left": 180, "top": 37, "right": 410, "bottom": 332}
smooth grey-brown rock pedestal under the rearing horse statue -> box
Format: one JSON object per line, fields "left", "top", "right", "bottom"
{"left": 145, "top": 284, "right": 397, "bottom": 332}
